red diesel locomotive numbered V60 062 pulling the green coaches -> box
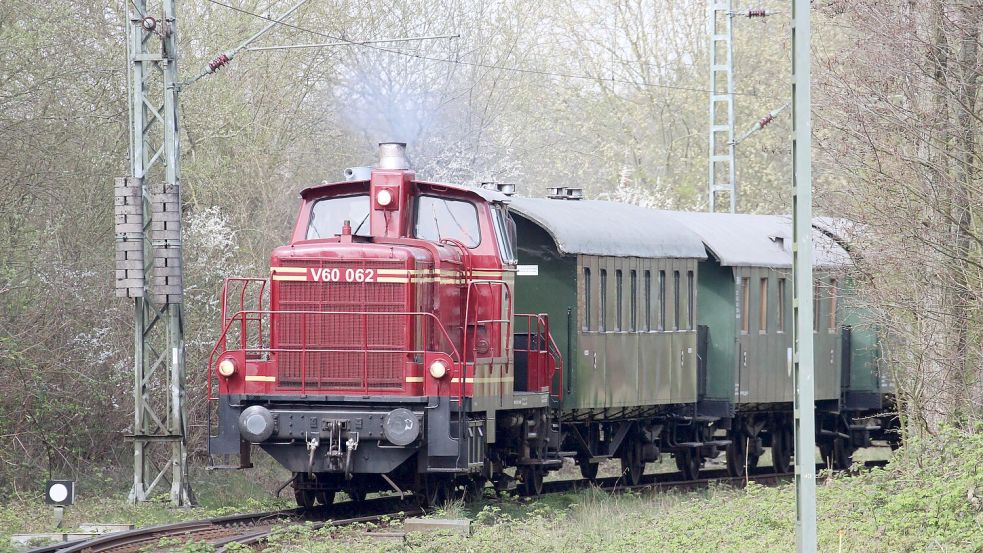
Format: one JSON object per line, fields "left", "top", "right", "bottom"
{"left": 209, "top": 143, "right": 562, "bottom": 507}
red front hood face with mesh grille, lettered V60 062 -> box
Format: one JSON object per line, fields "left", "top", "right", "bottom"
{"left": 274, "top": 260, "right": 412, "bottom": 391}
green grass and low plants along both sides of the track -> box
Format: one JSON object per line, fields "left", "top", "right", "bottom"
{"left": 0, "top": 433, "right": 983, "bottom": 553}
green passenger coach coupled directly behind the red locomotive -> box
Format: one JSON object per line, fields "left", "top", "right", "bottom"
{"left": 510, "top": 198, "right": 726, "bottom": 480}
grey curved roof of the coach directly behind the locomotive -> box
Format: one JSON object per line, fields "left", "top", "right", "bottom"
{"left": 509, "top": 196, "right": 706, "bottom": 259}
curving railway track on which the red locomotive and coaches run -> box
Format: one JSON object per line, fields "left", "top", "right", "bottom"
{"left": 27, "top": 461, "right": 885, "bottom": 553}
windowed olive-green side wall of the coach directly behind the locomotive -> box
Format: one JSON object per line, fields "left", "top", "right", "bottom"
{"left": 570, "top": 255, "right": 698, "bottom": 409}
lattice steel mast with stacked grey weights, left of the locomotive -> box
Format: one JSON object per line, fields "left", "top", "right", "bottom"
{"left": 115, "top": 0, "right": 194, "bottom": 506}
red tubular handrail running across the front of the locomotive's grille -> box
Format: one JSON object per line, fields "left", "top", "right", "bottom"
{"left": 207, "top": 309, "right": 464, "bottom": 401}
